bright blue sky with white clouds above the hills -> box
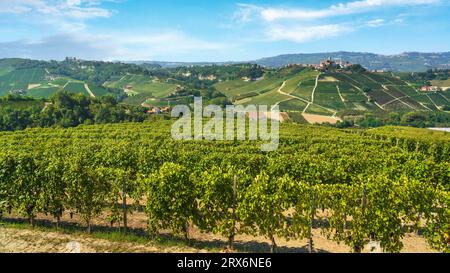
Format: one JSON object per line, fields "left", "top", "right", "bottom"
{"left": 0, "top": 0, "right": 450, "bottom": 61}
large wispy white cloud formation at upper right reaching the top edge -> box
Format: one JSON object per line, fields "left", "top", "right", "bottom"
{"left": 233, "top": 0, "right": 443, "bottom": 43}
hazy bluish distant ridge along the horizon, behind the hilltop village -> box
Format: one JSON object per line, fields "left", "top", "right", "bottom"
{"left": 134, "top": 51, "right": 450, "bottom": 72}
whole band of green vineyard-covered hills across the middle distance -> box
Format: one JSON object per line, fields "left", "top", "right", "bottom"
{"left": 0, "top": 59, "right": 450, "bottom": 126}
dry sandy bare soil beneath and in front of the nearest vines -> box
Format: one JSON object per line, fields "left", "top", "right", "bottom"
{"left": 0, "top": 210, "right": 435, "bottom": 253}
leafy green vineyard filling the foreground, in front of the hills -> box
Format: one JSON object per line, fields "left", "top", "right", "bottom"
{"left": 0, "top": 120, "right": 450, "bottom": 252}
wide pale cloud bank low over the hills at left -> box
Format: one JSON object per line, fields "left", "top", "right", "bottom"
{"left": 0, "top": 30, "right": 232, "bottom": 60}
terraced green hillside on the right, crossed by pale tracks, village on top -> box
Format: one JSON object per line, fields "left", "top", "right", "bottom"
{"left": 215, "top": 68, "right": 450, "bottom": 120}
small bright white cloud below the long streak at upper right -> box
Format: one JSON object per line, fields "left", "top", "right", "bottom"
{"left": 266, "top": 25, "right": 353, "bottom": 43}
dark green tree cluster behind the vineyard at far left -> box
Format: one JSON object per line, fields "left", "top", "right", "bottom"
{"left": 0, "top": 92, "right": 146, "bottom": 131}
